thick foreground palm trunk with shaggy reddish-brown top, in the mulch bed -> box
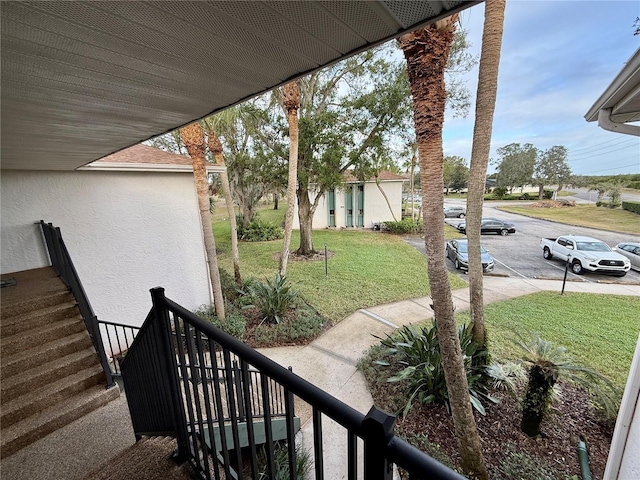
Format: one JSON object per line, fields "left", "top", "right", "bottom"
{"left": 399, "top": 15, "right": 488, "bottom": 479}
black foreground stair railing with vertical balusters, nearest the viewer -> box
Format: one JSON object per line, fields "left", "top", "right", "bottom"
{"left": 122, "top": 288, "right": 464, "bottom": 480}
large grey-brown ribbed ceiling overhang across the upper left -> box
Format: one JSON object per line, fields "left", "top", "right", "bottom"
{"left": 0, "top": 0, "right": 479, "bottom": 170}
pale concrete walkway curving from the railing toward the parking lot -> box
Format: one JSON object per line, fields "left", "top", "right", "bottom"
{"left": 260, "top": 276, "right": 640, "bottom": 479}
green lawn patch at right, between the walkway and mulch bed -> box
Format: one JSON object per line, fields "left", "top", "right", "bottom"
{"left": 458, "top": 292, "right": 640, "bottom": 388}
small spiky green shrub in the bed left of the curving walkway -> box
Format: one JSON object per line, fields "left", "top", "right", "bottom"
{"left": 246, "top": 273, "right": 298, "bottom": 323}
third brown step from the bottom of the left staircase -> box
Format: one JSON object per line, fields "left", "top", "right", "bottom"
{"left": 0, "top": 348, "right": 100, "bottom": 405}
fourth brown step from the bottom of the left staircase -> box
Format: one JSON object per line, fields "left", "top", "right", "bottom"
{"left": 0, "top": 330, "right": 93, "bottom": 382}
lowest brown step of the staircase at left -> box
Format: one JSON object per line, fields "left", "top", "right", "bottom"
{"left": 0, "top": 385, "right": 120, "bottom": 458}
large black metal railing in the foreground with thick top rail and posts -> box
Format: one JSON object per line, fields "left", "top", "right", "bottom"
{"left": 121, "top": 288, "right": 464, "bottom": 480}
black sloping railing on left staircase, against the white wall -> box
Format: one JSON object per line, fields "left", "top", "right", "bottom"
{"left": 40, "top": 220, "right": 115, "bottom": 388}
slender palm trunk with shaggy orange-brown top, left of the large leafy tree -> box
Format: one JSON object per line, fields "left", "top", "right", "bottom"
{"left": 280, "top": 82, "right": 300, "bottom": 277}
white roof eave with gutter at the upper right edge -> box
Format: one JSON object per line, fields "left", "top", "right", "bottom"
{"left": 585, "top": 48, "right": 640, "bottom": 136}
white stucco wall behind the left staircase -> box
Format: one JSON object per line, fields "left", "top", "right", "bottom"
{"left": 0, "top": 171, "right": 211, "bottom": 325}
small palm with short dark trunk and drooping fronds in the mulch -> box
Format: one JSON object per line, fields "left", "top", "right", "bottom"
{"left": 515, "top": 332, "right": 617, "bottom": 437}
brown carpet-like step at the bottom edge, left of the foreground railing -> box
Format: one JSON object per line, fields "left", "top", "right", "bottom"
{"left": 83, "top": 437, "right": 196, "bottom": 480}
